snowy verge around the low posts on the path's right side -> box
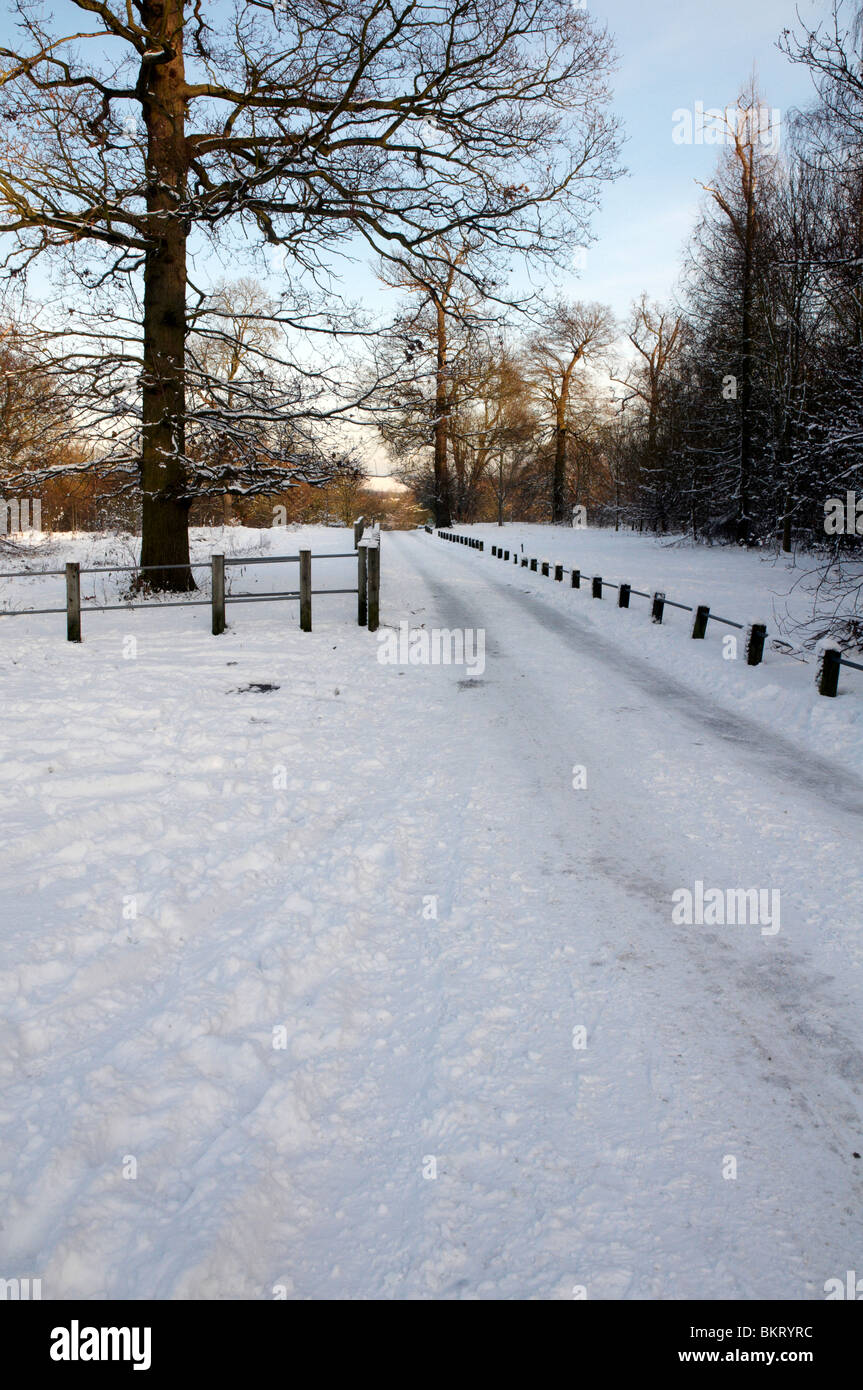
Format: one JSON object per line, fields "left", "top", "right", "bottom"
{"left": 458, "top": 525, "right": 863, "bottom": 770}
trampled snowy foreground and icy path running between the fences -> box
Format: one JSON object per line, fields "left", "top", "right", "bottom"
{"left": 0, "top": 534, "right": 863, "bottom": 1298}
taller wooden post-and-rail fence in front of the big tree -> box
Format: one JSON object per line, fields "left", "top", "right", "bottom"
{"left": 0, "top": 530, "right": 381, "bottom": 642}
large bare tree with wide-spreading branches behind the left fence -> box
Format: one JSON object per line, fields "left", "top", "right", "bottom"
{"left": 0, "top": 0, "right": 617, "bottom": 588}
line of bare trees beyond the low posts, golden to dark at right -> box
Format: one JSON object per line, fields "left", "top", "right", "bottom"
{"left": 381, "top": 0, "right": 863, "bottom": 555}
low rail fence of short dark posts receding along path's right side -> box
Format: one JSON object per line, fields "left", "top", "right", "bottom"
{"left": 425, "top": 527, "right": 863, "bottom": 695}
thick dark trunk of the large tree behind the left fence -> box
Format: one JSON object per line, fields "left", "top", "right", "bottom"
{"left": 139, "top": 0, "right": 196, "bottom": 592}
